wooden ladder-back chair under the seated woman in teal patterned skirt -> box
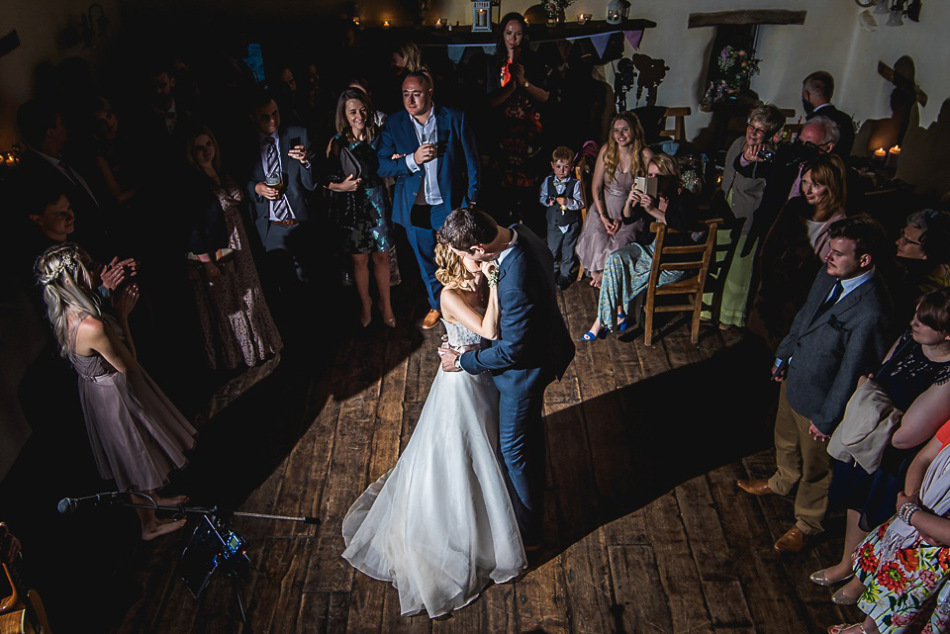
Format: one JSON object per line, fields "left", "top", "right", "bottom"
{"left": 643, "top": 218, "right": 722, "bottom": 346}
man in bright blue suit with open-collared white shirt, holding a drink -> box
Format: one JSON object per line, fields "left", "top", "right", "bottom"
{"left": 378, "top": 72, "right": 479, "bottom": 329}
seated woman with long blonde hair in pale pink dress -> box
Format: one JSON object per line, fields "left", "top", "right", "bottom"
{"left": 577, "top": 112, "right": 653, "bottom": 288}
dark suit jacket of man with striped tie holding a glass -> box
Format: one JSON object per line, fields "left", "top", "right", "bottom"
{"left": 245, "top": 126, "right": 317, "bottom": 243}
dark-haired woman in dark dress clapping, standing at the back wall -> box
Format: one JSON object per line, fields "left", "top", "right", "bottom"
{"left": 487, "top": 12, "right": 549, "bottom": 226}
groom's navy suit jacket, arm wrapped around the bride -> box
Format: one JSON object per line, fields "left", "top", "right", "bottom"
{"left": 460, "top": 224, "right": 574, "bottom": 384}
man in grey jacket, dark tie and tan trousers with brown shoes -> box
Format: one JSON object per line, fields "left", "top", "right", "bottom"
{"left": 737, "top": 217, "right": 890, "bottom": 552}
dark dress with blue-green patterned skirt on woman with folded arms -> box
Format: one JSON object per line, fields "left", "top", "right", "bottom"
{"left": 327, "top": 133, "right": 393, "bottom": 253}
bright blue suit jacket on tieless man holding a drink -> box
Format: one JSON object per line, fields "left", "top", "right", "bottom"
{"left": 377, "top": 107, "right": 480, "bottom": 229}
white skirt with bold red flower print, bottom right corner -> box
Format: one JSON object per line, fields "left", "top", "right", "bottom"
{"left": 852, "top": 504, "right": 950, "bottom": 634}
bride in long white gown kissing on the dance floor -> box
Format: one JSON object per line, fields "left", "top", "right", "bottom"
{"left": 343, "top": 244, "right": 527, "bottom": 618}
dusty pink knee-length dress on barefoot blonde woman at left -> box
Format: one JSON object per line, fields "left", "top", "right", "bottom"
{"left": 69, "top": 321, "right": 197, "bottom": 491}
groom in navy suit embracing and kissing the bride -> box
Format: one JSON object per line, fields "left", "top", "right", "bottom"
{"left": 439, "top": 208, "right": 574, "bottom": 550}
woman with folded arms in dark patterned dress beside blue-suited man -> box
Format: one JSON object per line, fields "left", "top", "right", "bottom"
{"left": 326, "top": 88, "right": 396, "bottom": 328}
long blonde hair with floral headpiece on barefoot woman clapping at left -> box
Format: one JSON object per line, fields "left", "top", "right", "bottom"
{"left": 34, "top": 242, "right": 102, "bottom": 357}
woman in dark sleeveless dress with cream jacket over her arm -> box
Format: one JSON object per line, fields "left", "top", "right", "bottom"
{"left": 811, "top": 288, "right": 950, "bottom": 605}
